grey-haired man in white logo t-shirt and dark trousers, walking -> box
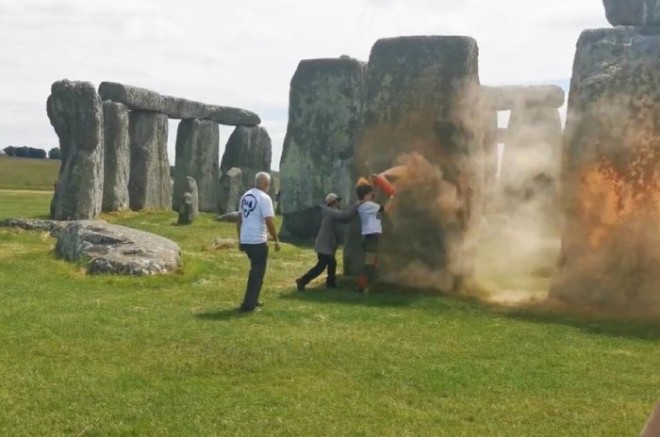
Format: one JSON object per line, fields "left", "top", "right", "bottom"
{"left": 236, "top": 172, "right": 280, "bottom": 312}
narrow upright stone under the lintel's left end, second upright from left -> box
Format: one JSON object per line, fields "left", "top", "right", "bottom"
{"left": 103, "top": 101, "right": 131, "bottom": 212}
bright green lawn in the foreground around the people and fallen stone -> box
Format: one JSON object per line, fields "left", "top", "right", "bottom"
{"left": 0, "top": 193, "right": 660, "bottom": 436}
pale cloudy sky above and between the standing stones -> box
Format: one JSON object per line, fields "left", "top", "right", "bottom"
{"left": 0, "top": 0, "right": 609, "bottom": 169}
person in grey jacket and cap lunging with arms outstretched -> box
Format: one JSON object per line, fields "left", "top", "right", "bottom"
{"left": 296, "top": 193, "right": 358, "bottom": 291}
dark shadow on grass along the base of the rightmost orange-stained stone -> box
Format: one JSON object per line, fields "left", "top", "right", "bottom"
{"left": 507, "top": 308, "right": 660, "bottom": 342}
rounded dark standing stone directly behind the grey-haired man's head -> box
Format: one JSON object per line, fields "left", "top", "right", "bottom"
{"left": 219, "top": 126, "right": 274, "bottom": 214}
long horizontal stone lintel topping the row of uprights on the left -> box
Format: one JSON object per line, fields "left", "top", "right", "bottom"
{"left": 99, "top": 82, "right": 261, "bottom": 126}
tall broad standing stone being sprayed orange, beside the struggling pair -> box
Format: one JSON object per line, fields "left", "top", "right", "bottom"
{"left": 345, "top": 36, "right": 484, "bottom": 291}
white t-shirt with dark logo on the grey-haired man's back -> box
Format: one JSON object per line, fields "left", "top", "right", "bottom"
{"left": 238, "top": 188, "right": 275, "bottom": 244}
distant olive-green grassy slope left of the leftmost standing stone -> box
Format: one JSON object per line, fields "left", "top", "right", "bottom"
{"left": 0, "top": 156, "right": 60, "bottom": 192}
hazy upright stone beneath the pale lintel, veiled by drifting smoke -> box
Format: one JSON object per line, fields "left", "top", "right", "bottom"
{"left": 499, "top": 105, "right": 562, "bottom": 228}
